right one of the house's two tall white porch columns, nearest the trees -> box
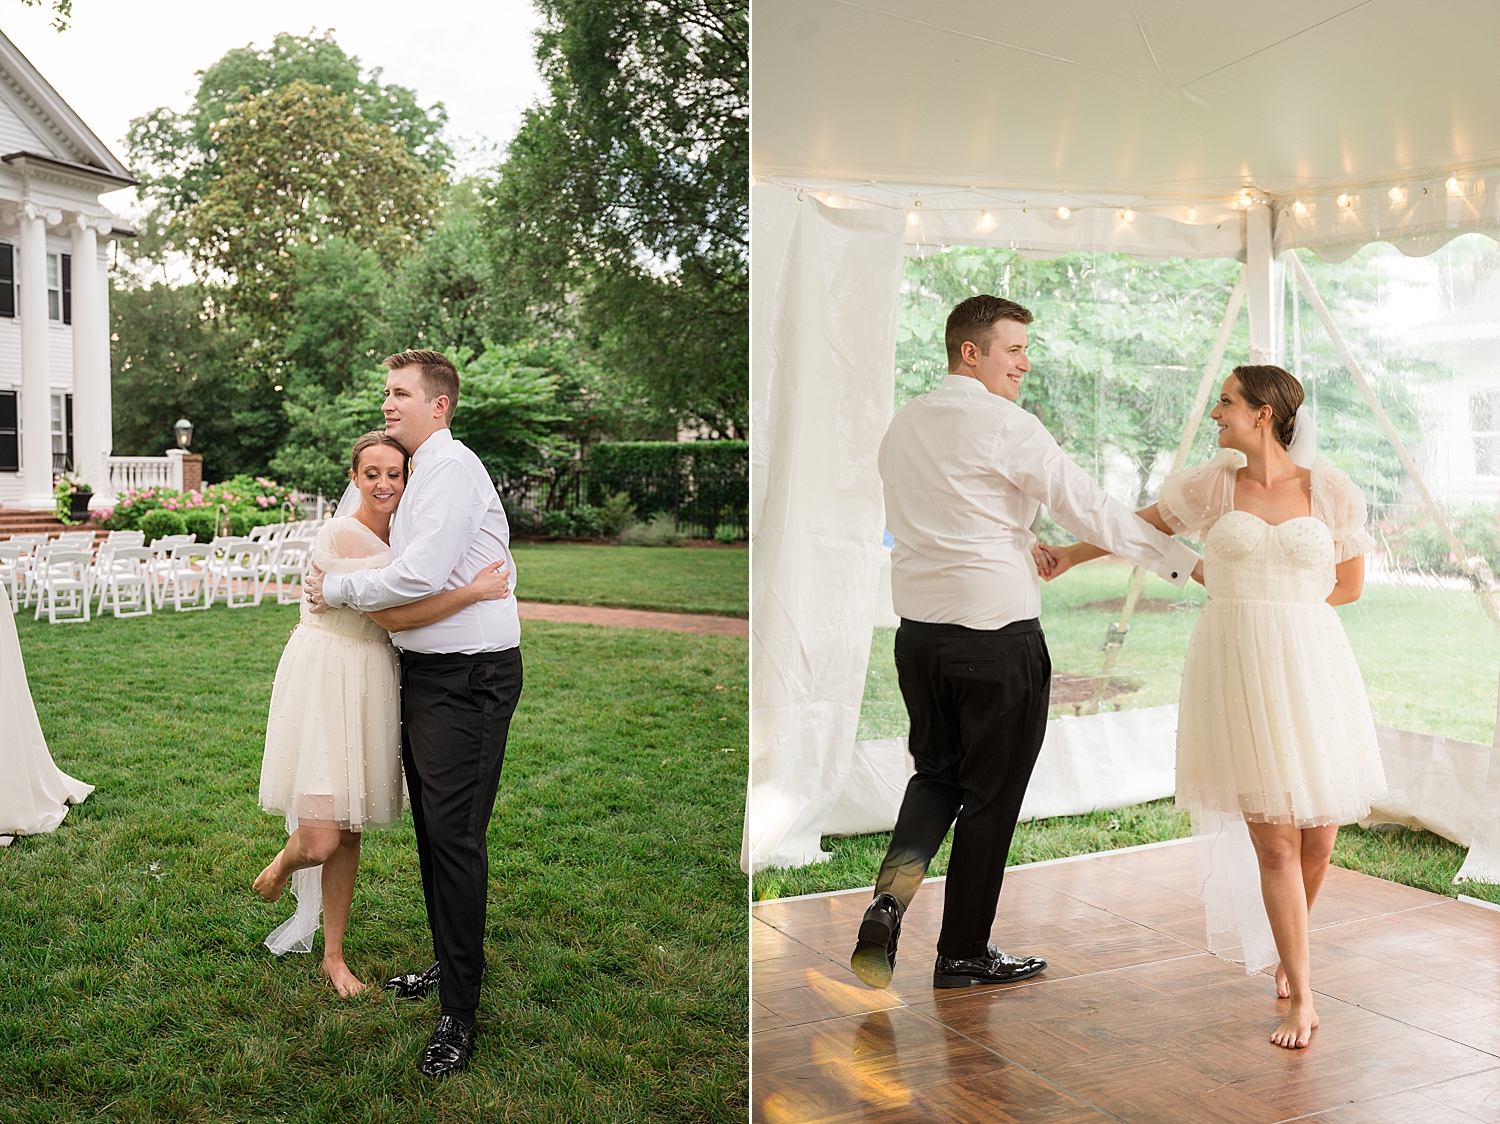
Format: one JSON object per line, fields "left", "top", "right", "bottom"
{"left": 69, "top": 215, "right": 111, "bottom": 501}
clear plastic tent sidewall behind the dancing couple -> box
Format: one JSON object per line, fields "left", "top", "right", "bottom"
{"left": 858, "top": 234, "right": 1500, "bottom": 744}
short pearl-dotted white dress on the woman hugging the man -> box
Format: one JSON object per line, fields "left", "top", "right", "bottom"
{"left": 261, "top": 518, "right": 402, "bottom": 831}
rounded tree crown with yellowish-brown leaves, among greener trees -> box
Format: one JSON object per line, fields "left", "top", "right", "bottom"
{"left": 185, "top": 78, "right": 441, "bottom": 342}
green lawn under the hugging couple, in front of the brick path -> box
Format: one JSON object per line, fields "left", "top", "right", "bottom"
{"left": 0, "top": 606, "right": 747, "bottom": 1124}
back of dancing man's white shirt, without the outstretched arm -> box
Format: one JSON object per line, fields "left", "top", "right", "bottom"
{"left": 881, "top": 375, "right": 1046, "bottom": 629}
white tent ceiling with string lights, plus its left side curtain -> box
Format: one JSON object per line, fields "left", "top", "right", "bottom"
{"left": 756, "top": 0, "right": 1500, "bottom": 869}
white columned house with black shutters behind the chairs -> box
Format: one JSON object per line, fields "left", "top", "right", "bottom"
{"left": 0, "top": 27, "right": 135, "bottom": 510}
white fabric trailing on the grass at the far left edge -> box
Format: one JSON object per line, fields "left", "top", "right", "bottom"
{"left": 0, "top": 588, "right": 91, "bottom": 836}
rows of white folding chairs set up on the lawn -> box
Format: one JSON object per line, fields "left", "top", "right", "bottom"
{"left": 0, "top": 521, "right": 321, "bottom": 624}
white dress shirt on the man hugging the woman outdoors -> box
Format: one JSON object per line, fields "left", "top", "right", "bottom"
{"left": 323, "top": 429, "right": 521, "bottom": 654}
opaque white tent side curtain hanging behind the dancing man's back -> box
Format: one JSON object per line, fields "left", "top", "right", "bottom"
{"left": 741, "top": 185, "right": 905, "bottom": 870}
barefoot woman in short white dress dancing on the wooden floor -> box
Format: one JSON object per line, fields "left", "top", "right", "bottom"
{"left": 1046, "top": 366, "right": 1385, "bottom": 1049}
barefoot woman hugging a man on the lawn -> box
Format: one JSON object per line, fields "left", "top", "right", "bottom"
{"left": 255, "top": 429, "right": 510, "bottom": 998}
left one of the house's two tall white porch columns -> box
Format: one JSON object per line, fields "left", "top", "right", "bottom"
{"left": 15, "top": 203, "right": 62, "bottom": 510}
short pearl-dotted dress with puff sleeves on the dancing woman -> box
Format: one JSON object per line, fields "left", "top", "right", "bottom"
{"left": 1157, "top": 450, "right": 1386, "bottom": 827}
